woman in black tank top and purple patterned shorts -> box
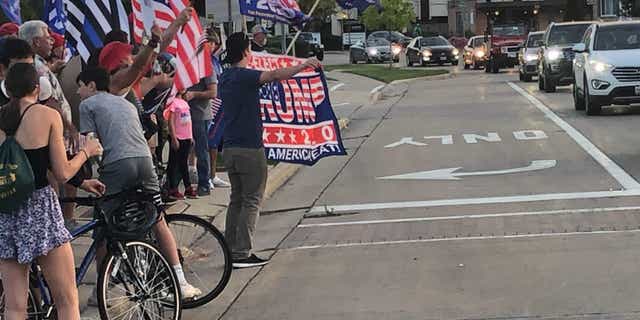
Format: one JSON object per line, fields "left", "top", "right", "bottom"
{"left": 0, "top": 63, "right": 102, "bottom": 320}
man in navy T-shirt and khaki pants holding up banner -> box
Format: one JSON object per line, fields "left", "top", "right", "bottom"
{"left": 219, "top": 33, "right": 320, "bottom": 268}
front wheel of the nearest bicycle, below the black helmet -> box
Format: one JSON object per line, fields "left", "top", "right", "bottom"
{"left": 98, "top": 241, "right": 182, "bottom": 320}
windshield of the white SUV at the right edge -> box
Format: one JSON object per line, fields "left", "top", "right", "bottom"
{"left": 594, "top": 24, "right": 640, "bottom": 50}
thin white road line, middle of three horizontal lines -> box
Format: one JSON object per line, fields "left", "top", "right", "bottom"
{"left": 298, "top": 207, "right": 640, "bottom": 228}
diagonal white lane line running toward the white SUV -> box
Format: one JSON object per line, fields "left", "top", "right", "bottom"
{"left": 507, "top": 81, "right": 640, "bottom": 190}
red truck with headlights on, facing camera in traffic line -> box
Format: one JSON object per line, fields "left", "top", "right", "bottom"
{"left": 485, "top": 25, "right": 527, "bottom": 73}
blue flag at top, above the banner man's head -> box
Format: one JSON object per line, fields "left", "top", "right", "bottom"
{"left": 239, "top": 0, "right": 310, "bottom": 29}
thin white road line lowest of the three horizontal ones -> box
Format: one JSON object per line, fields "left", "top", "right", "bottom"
{"left": 283, "top": 229, "right": 640, "bottom": 250}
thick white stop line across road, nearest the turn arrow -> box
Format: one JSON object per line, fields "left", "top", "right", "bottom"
{"left": 305, "top": 190, "right": 640, "bottom": 217}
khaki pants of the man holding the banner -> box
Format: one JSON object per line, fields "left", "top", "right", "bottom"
{"left": 222, "top": 148, "right": 267, "bottom": 260}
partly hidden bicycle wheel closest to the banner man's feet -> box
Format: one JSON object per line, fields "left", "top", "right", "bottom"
{"left": 165, "top": 214, "right": 232, "bottom": 309}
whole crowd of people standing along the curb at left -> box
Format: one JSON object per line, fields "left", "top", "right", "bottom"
{"left": 0, "top": 8, "right": 319, "bottom": 319}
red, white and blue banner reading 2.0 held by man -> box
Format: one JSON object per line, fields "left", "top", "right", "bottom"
{"left": 248, "top": 53, "right": 347, "bottom": 166}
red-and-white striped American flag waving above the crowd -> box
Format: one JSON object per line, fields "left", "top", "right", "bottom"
{"left": 131, "top": 0, "right": 213, "bottom": 91}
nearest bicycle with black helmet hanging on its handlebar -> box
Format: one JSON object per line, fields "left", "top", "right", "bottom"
{"left": 0, "top": 189, "right": 182, "bottom": 320}
